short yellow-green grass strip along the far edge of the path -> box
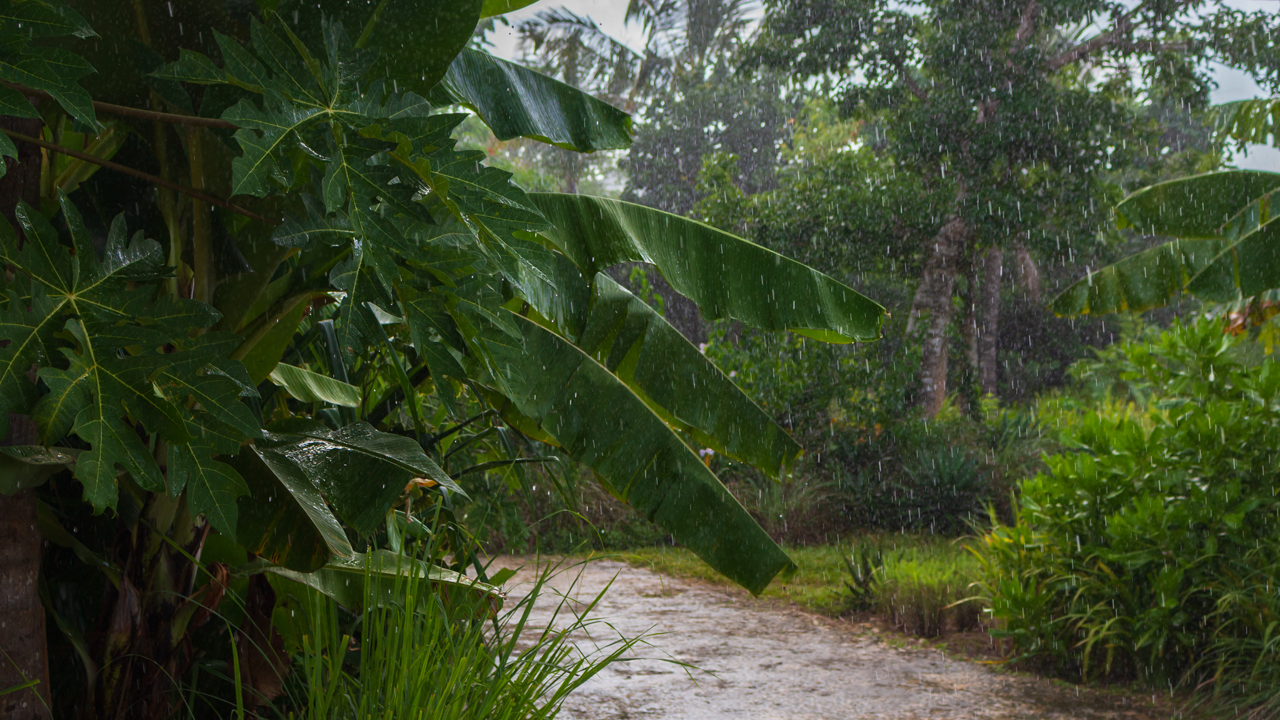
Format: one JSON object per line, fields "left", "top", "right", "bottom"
{"left": 621, "top": 534, "right": 978, "bottom": 625}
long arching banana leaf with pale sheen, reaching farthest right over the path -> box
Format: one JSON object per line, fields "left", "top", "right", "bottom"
{"left": 530, "top": 193, "right": 884, "bottom": 342}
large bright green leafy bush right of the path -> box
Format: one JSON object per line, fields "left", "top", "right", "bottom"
{"left": 982, "top": 320, "right": 1280, "bottom": 702}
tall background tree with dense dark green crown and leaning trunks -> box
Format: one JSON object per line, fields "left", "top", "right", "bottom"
{"left": 754, "top": 0, "right": 1274, "bottom": 414}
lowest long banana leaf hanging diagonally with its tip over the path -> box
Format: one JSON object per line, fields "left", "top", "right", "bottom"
{"left": 493, "top": 311, "right": 795, "bottom": 593}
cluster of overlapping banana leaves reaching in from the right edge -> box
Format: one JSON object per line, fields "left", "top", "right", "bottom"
{"left": 1051, "top": 170, "right": 1280, "bottom": 315}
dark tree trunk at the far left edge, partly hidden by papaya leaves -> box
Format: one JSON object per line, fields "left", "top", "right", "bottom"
{"left": 0, "top": 112, "right": 50, "bottom": 720}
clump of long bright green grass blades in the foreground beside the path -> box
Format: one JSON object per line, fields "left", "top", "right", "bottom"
{"left": 285, "top": 545, "right": 641, "bottom": 720}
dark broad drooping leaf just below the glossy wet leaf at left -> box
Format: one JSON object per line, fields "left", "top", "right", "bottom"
{"left": 232, "top": 448, "right": 356, "bottom": 573}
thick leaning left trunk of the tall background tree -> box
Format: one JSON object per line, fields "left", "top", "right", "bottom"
{"left": 908, "top": 212, "right": 968, "bottom": 418}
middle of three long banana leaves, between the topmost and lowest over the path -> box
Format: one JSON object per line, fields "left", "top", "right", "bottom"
{"left": 577, "top": 274, "right": 801, "bottom": 477}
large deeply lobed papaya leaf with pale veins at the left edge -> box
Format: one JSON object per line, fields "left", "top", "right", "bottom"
{"left": 0, "top": 195, "right": 259, "bottom": 510}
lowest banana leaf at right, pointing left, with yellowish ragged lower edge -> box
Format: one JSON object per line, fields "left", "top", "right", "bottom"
{"left": 1050, "top": 240, "right": 1234, "bottom": 316}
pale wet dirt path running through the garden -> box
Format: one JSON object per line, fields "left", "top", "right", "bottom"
{"left": 498, "top": 557, "right": 1169, "bottom": 720}
